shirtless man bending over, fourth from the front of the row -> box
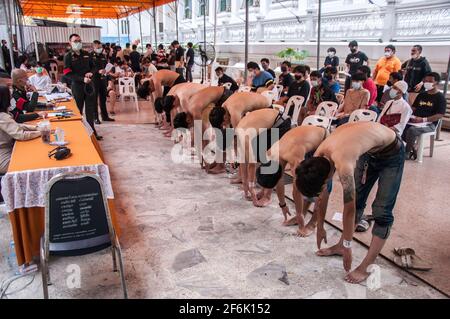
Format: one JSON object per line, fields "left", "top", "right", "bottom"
{"left": 209, "top": 92, "right": 270, "bottom": 176}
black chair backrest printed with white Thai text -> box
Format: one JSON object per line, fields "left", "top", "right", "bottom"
{"left": 49, "top": 176, "right": 111, "bottom": 255}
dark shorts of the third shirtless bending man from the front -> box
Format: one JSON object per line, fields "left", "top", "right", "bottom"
{"left": 252, "top": 118, "right": 291, "bottom": 163}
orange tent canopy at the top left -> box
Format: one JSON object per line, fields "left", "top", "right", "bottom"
{"left": 20, "top": 0, "right": 175, "bottom": 19}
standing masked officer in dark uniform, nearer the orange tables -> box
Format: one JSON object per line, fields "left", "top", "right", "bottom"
{"left": 64, "top": 34, "right": 102, "bottom": 140}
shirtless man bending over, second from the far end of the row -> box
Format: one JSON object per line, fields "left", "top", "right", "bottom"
{"left": 157, "top": 82, "right": 207, "bottom": 137}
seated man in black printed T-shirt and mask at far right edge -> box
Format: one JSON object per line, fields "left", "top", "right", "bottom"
{"left": 403, "top": 72, "right": 447, "bottom": 160}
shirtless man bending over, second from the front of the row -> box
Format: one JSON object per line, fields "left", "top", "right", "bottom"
{"left": 256, "top": 125, "right": 328, "bottom": 237}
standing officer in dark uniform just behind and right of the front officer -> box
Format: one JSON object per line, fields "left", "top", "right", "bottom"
{"left": 91, "top": 40, "right": 114, "bottom": 124}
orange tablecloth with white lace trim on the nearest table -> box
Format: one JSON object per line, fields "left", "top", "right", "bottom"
{"left": 3, "top": 116, "right": 120, "bottom": 265}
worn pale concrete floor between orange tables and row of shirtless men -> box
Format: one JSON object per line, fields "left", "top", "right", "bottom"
{"left": 0, "top": 102, "right": 444, "bottom": 298}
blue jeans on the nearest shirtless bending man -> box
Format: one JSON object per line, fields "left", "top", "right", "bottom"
{"left": 355, "top": 144, "right": 405, "bottom": 239}
